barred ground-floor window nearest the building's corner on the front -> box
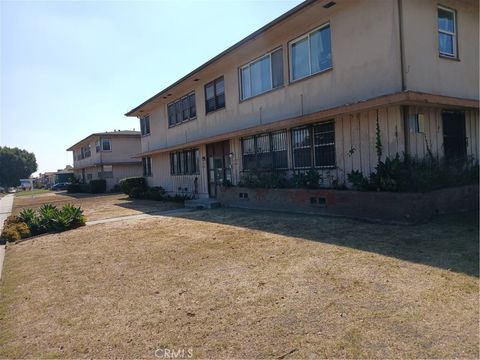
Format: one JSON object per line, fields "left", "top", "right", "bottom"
{"left": 292, "top": 120, "right": 336, "bottom": 169}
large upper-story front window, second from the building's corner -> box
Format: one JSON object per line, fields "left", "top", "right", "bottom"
{"left": 240, "top": 48, "right": 283, "bottom": 100}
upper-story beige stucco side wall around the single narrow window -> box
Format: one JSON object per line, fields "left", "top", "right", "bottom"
{"left": 402, "top": 0, "right": 479, "bottom": 99}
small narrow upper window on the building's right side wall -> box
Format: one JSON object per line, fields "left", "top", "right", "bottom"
{"left": 438, "top": 7, "right": 457, "bottom": 58}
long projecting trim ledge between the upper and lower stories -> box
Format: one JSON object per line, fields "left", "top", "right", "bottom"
{"left": 133, "top": 91, "right": 479, "bottom": 158}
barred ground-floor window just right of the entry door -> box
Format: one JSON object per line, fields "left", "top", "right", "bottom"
{"left": 242, "top": 130, "right": 288, "bottom": 170}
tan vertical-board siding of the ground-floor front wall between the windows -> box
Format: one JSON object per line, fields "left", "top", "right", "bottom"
{"left": 147, "top": 106, "right": 405, "bottom": 191}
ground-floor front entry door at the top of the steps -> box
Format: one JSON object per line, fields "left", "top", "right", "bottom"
{"left": 207, "top": 140, "right": 232, "bottom": 198}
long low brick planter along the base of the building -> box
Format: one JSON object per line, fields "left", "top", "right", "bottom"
{"left": 217, "top": 184, "right": 479, "bottom": 223}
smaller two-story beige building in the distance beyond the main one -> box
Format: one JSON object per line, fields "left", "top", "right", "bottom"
{"left": 67, "top": 130, "right": 142, "bottom": 190}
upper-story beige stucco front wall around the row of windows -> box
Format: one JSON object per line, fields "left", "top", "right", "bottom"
{"left": 142, "top": 0, "right": 401, "bottom": 151}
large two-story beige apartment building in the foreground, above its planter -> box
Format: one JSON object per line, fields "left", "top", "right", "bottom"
{"left": 126, "top": 0, "right": 479, "bottom": 197}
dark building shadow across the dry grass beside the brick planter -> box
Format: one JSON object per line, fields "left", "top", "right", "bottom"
{"left": 171, "top": 208, "right": 479, "bottom": 281}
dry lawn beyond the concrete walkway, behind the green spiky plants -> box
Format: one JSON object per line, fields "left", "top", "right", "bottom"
{"left": 12, "top": 192, "right": 183, "bottom": 221}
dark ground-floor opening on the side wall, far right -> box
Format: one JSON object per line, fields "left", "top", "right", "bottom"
{"left": 442, "top": 110, "right": 467, "bottom": 160}
